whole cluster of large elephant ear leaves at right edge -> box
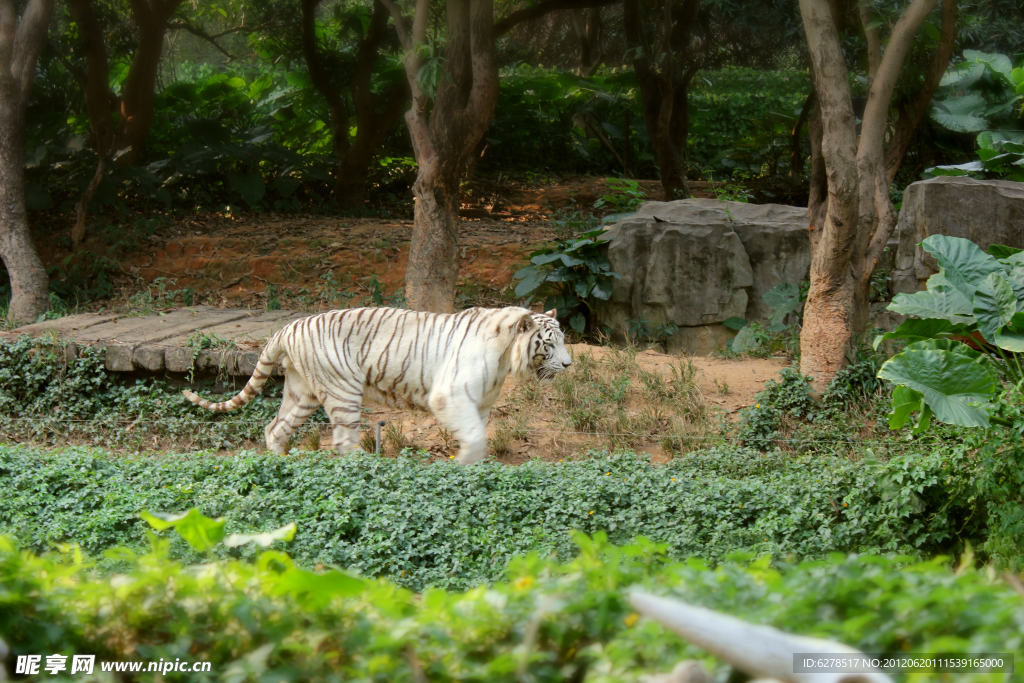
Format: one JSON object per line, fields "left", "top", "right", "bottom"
{"left": 874, "top": 234, "right": 1024, "bottom": 432}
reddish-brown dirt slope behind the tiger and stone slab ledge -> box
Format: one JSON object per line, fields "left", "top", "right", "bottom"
{"left": 38, "top": 177, "right": 713, "bottom": 310}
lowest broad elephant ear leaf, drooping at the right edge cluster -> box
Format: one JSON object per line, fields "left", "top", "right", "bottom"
{"left": 879, "top": 348, "right": 998, "bottom": 427}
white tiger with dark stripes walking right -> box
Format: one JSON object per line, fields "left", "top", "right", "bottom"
{"left": 183, "top": 306, "right": 572, "bottom": 465}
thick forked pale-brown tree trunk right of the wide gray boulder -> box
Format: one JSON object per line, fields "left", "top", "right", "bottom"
{"left": 800, "top": 0, "right": 937, "bottom": 391}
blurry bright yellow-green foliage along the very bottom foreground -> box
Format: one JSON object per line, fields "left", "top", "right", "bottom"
{"left": 0, "top": 518, "right": 1024, "bottom": 683}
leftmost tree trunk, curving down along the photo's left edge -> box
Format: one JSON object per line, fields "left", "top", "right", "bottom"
{"left": 0, "top": 0, "right": 53, "bottom": 323}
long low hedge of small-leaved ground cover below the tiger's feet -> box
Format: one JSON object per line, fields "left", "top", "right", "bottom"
{"left": 0, "top": 445, "right": 979, "bottom": 590}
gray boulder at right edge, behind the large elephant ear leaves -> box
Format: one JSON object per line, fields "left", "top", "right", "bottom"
{"left": 891, "top": 176, "right": 1024, "bottom": 292}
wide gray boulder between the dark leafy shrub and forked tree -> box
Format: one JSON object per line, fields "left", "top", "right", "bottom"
{"left": 602, "top": 199, "right": 810, "bottom": 353}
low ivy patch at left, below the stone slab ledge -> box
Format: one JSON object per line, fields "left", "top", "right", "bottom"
{"left": 0, "top": 335, "right": 326, "bottom": 449}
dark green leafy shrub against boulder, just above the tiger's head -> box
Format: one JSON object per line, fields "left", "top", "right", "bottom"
{"left": 513, "top": 228, "right": 621, "bottom": 334}
